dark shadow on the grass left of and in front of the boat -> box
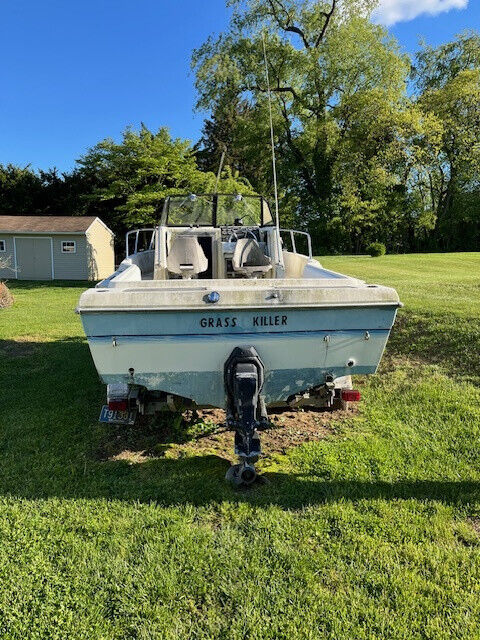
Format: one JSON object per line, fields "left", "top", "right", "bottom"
{"left": 0, "top": 338, "right": 480, "bottom": 509}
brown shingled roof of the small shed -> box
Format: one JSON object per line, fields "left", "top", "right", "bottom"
{"left": 0, "top": 216, "right": 110, "bottom": 233}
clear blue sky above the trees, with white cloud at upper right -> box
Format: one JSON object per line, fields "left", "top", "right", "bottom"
{"left": 0, "top": 0, "right": 480, "bottom": 170}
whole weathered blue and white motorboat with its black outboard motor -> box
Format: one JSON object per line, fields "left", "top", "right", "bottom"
{"left": 78, "top": 194, "right": 400, "bottom": 484}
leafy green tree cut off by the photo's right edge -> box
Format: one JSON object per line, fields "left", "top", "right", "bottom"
{"left": 414, "top": 32, "right": 480, "bottom": 250}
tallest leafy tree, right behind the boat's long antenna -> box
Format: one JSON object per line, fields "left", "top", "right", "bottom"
{"left": 193, "top": 0, "right": 415, "bottom": 246}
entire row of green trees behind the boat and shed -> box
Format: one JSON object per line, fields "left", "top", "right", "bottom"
{"left": 0, "top": 0, "right": 480, "bottom": 253}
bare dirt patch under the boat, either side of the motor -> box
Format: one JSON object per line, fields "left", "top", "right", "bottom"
{"left": 96, "top": 409, "right": 352, "bottom": 464}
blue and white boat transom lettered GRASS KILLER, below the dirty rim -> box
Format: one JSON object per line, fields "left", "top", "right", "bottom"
{"left": 82, "top": 304, "right": 398, "bottom": 407}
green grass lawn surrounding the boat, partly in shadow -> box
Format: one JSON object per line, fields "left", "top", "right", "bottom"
{"left": 0, "top": 254, "right": 480, "bottom": 640}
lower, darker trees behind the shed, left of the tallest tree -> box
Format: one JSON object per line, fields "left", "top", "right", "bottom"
{"left": 0, "top": 129, "right": 254, "bottom": 251}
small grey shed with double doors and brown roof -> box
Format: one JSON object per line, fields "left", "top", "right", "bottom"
{"left": 0, "top": 215, "right": 115, "bottom": 280}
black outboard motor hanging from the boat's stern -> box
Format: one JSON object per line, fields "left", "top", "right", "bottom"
{"left": 225, "top": 347, "right": 267, "bottom": 485}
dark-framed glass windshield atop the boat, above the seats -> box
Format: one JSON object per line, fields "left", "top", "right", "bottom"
{"left": 161, "top": 194, "right": 273, "bottom": 227}
